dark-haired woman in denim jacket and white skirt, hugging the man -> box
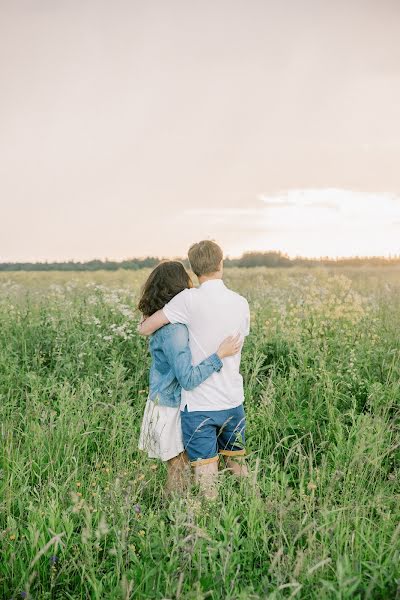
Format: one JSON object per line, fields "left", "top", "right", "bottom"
{"left": 138, "top": 261, "right": 240, "bottom": 493}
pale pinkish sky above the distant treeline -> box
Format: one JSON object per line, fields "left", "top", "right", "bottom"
{"left": 0, "top": 0, "right": 400, "bottom": 261}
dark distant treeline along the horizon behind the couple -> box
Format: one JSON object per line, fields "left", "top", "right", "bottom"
{"left": 0, "top": 252, "right": 400, "bottom": 271}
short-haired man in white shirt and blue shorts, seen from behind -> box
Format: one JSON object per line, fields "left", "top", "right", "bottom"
{"left": 139, "top": 240, "right": 250, "bottom": 496}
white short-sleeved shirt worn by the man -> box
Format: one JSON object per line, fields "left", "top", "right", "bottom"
{"left": 163, "top": 279, "right": 250, "bottom": 412}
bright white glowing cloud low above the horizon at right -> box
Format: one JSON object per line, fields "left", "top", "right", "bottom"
{"left": 178, "top": 188, "right": 400, "bottom": 256}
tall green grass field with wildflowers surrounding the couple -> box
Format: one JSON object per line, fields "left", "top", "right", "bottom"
{"left": 0, "top": 267, "right": 400, "bottom": 600}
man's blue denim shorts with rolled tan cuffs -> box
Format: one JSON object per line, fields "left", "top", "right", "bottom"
{"left": 181, "top": 404, "right": 246, "bottom": 465}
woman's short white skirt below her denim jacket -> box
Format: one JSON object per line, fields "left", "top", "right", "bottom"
{"left": 139, "top": 398, "right": 184, "bottom": 461}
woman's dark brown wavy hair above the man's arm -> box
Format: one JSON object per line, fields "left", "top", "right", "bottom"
{"left": 138, "top": 260, "right": 193, "bottom": 317}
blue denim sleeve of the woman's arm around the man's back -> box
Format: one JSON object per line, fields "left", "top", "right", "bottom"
{"left": 163, "top": 325, "right": 223, "bottom": 390}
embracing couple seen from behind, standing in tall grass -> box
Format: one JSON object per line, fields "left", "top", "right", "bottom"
{"left": 138, "top": 240, "right": 250, "bottom": 498}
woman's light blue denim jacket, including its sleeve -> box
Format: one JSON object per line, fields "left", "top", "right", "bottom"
{"left": 150, "top": 323, "right": 222, "bottom": 406}
